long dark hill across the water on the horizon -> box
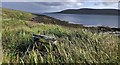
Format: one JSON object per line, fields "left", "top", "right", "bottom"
{"left": 54, "top": 8, "right": 120, "bottom": 15}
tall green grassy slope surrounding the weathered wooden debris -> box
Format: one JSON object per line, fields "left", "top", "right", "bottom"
{"left": 2, "top": 9, "right": 118, "bottom": 63}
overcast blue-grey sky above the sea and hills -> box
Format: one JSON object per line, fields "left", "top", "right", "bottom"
{"left": 2, "top": 0, "right": 118, "bottom": 13}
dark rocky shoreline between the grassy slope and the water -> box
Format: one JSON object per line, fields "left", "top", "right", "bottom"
{"left": 30, "top": 14, "right": 120, "bottom": 32}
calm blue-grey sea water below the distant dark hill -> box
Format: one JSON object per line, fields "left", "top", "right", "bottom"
{"left": 44, "top": 14, "right": 118, "bottom": 27}
